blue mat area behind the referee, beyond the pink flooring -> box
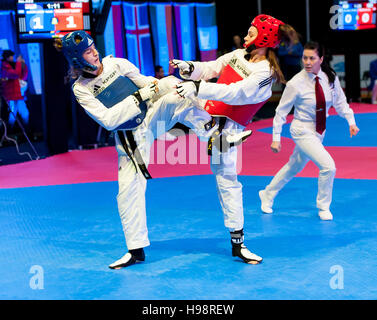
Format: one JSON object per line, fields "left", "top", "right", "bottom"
{"left": 259, "top": 113, "right": 377, "bottom": 147}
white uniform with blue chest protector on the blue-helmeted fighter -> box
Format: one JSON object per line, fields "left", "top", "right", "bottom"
{"left": 73, "top": 56, "right": 216, "bottom": 250}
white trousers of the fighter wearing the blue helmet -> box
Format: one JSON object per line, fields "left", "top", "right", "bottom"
{"left": 115, "top": 93, "right": 216, "bottom": 250}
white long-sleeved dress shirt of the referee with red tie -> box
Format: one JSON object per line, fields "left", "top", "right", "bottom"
{"left": 273, "top": 69, "right": 355, "bottom": 141}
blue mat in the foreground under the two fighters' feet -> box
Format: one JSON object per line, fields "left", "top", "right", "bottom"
{"left": 0, "top": 176, "right": 377, "bottom": 300}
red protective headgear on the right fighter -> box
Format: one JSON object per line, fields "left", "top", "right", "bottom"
{"left": 245, "top": 14, "right": 284, "bottom": 48}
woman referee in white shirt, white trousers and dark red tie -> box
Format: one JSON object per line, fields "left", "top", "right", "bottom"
{"left": 259, "top": 42, "right": 359, "bottom": 220}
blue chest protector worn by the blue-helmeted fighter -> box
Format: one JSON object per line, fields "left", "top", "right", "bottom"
{"left": 96, "top": 76, "right": 148, "bottom": 131}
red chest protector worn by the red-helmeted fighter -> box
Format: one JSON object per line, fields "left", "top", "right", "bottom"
{"left": 204, "top": 57, "right": 267, "bottom": 127}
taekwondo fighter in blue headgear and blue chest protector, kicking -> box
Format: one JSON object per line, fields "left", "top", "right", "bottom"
{"left": 60, "top": 31, "right": 235, "bottom": 269}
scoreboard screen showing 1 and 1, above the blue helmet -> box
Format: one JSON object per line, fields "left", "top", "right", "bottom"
{"left": 16, "top": 0, "right": 91, "bottom": 42}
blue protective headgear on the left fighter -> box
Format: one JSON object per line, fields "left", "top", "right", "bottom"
{"left": 62, "top": 30, "right": 102, "bottom": 71}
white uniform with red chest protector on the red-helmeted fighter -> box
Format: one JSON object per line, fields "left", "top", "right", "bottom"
{"left": 185, "top": 49, "right": 273, "bottom": 232}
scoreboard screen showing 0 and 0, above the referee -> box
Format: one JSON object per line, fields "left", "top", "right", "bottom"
{"left": 338, "top": 0, "right": 377, "bottom": 30}
